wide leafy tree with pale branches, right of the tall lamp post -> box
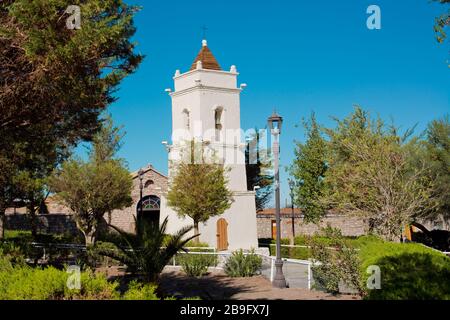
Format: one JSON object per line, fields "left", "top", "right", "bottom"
{"left": 325, "top": 107, "right": 435, "bottom": 240}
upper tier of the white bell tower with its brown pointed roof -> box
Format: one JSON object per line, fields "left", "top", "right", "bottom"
{"left": 169, "top": 40, "right": 247, "bottom": 191}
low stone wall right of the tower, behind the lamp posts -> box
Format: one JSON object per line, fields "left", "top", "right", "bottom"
{"left": 256, "top": 214, "right": 367, "bottom": 238}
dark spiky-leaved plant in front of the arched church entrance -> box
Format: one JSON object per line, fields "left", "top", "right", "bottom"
{"left": 96, "top": 217, "right": 198, "bottom": 282}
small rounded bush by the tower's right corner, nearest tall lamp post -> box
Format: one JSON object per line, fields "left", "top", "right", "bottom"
{"left": 224, "top": 249, "right": 262, "bottom": 277}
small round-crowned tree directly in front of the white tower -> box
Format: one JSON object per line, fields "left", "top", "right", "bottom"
{"left": 167, "top": 141, "right": 233, "bottom": 242}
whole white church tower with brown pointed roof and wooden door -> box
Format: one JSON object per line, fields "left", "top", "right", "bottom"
{"left": 164, "top": 40, "right": 257, "bottom": 250}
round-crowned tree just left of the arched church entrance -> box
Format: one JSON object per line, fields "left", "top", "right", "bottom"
{"left": 50, "top": 118, "right": 133, "bottom": 245}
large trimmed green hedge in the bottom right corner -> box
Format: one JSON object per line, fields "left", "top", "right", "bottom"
{"left": 360, "top": 242, "right": 450, "bottom": 300}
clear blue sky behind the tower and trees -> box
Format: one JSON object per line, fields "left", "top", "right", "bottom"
{"left": 83, "top": 0, "right": 450, "bottom": 204}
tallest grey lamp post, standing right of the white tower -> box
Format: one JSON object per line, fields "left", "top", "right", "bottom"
{"left": 268, "top": 111, "right": 286, "bottom": 289}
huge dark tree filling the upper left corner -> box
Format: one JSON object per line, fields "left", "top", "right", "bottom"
{"left": 0, "top": 0, "right": 142, "bottom": 231}
